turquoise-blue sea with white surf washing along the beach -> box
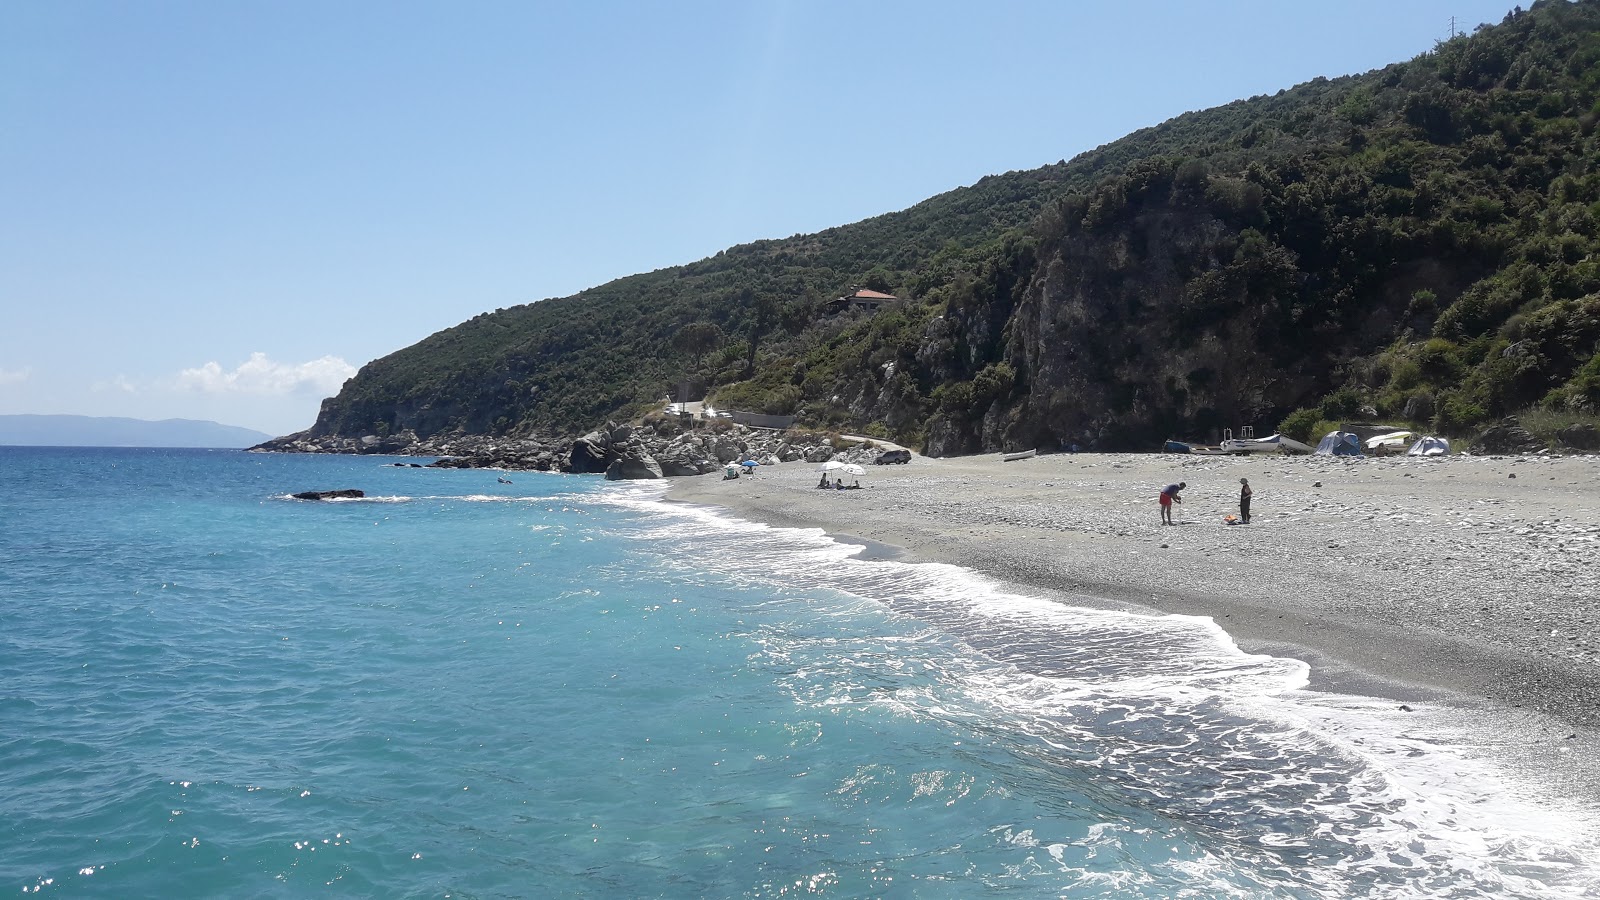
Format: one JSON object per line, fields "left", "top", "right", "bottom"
{"left": 0, "top": 448, "right": 1597, "bottom": 898}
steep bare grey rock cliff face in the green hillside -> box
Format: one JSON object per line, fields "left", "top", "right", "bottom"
{"left": 1004, "top": 208, "right": 1305, "bottom": 448}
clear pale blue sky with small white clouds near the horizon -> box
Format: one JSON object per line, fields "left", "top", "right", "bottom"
{"left": 0, "top": 0, "right": 1512, "bottom": 434}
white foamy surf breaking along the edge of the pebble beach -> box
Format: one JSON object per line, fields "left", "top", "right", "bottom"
{"left": 590, "top": 485, "right": 1600, "bottom": 897}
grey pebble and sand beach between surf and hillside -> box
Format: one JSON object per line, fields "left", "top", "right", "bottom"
{"left": 666, "top": 453, "right": 1600, "bottom": 804}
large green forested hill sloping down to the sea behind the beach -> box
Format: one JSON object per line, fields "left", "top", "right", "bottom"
{"left": 312, "top": 0, "right": 1600, "bottom": 455}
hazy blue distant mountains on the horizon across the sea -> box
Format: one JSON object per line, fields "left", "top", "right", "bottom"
{"left": 0, "top": 415, "right": 272, "bottom": 448}
